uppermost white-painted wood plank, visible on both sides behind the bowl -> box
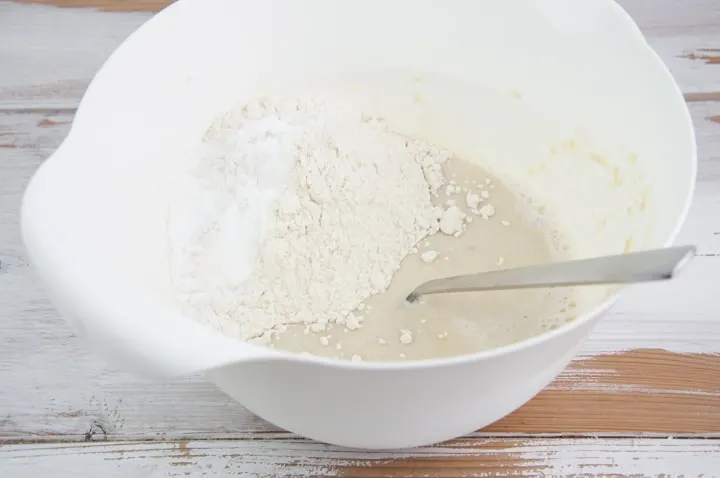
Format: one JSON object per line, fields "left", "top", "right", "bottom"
{"left": 0, "top": 0, "right": 720, "bottom": 108}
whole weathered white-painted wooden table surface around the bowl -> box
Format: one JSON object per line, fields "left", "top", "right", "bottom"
{"left": 0, "top": 0, "right": 720, "bottom": 478}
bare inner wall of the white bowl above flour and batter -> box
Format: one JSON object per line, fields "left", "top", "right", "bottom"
{"left": 32, "top": 0, "right": 694, "bottom": 344}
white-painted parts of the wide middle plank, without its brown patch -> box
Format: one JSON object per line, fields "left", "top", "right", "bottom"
{"left": 0, "top": 103, "right": 720, "bottom": 440}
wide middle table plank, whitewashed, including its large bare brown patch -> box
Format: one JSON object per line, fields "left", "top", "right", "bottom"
{"left": 0, "top": 102, "right": 720, "bottom": 441}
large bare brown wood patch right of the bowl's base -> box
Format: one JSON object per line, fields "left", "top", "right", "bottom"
{"left": 483, "top": 350, "right": 720, "bottom": 435}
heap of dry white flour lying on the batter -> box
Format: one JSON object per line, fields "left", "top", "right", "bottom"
{"left": 168, "top": 99, "right": 456, "bottom": 340}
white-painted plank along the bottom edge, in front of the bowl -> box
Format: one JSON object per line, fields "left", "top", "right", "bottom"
{"left": 0, "top": 437, "right": 720, "bottom": 478}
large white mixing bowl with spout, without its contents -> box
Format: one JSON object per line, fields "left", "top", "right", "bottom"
{"left": 22, "top": 0, "right": 696, "bottom": 448}
